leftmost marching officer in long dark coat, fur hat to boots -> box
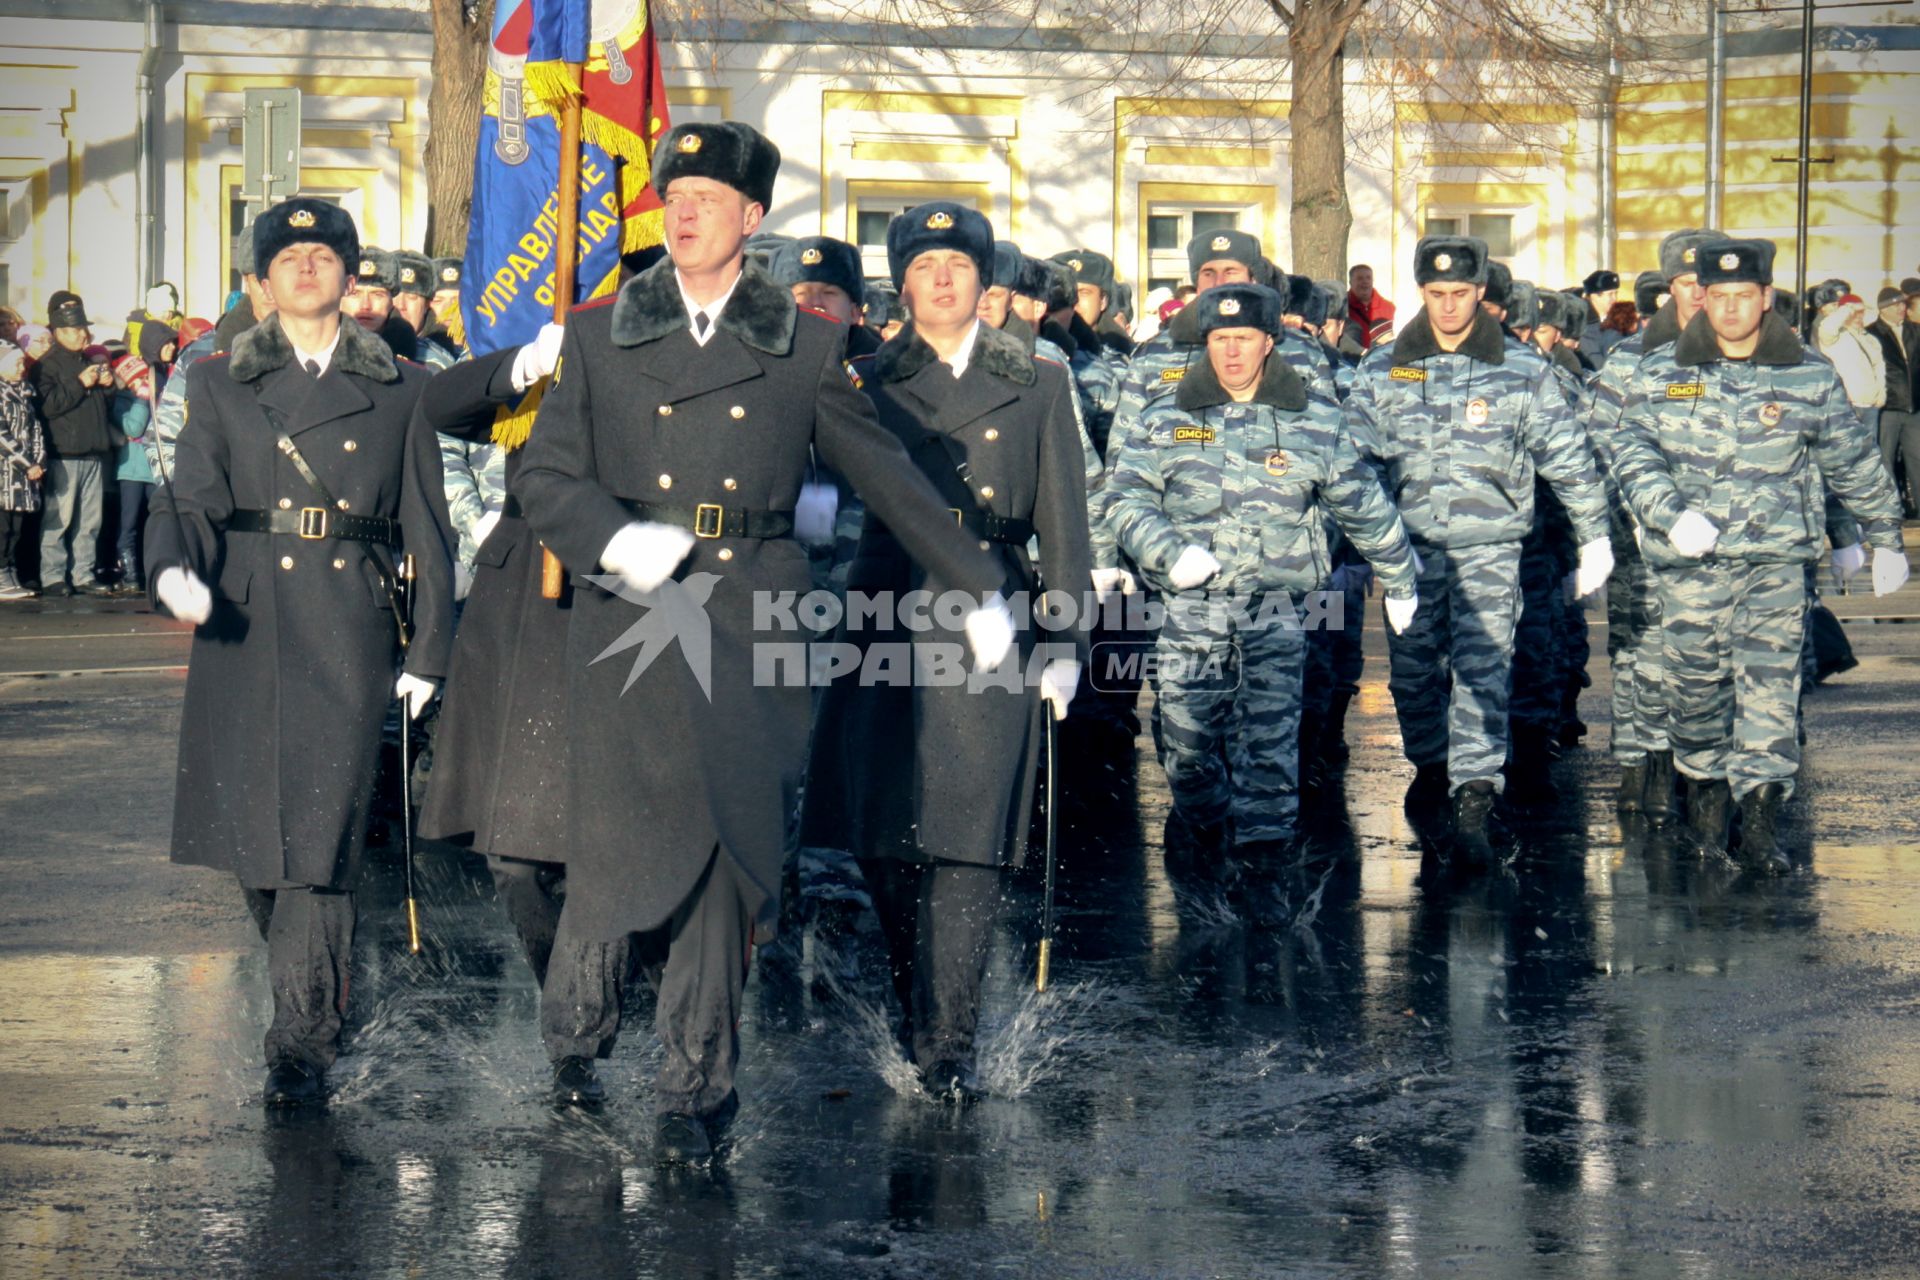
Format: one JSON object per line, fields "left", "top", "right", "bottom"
{"left": 146, "top": 200, "right": 451, "bottom": 1103}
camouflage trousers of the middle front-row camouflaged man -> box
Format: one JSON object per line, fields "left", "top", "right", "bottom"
{"left": 1386, "top": 543, "right": 1521, "bottom": 791}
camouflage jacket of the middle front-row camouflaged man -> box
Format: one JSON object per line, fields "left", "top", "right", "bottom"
{"left": 1346, "top": 313, "right": 1607, "bottom": 547}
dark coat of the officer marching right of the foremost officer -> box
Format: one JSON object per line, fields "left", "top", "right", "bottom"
{"left": 803, "top": 324, "right": 1092, "bottom": 865}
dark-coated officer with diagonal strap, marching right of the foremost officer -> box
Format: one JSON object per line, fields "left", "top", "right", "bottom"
{"left": 803, "top": 201, "right": 1092, "bottom": 1100}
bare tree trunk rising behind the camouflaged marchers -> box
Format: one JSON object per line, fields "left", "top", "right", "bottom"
{"left": 1286, "top": 10, "right": 1354, "bottom": 280}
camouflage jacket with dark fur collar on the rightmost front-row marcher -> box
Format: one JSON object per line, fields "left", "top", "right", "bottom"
{"left": 1611, "top": 315, "right": 1901, "bottom": 566}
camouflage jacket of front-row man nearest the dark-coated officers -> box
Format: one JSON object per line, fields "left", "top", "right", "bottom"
{"left": 1108, "top": 345, "right": 1415, "bottom": 595}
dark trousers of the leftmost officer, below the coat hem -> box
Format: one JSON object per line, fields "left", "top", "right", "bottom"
{"left": 242, "top": 887, "right": 353, "bottom": 1071}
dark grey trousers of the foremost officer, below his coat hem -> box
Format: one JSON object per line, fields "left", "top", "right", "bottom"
{"left": 540, "top": 850, "right": 753, "bottom": 1115}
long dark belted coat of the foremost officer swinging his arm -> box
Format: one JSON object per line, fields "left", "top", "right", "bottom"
{"left": 518, "top": 261, "right": 1006, "bottom": 938}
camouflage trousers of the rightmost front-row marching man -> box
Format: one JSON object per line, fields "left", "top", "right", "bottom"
{"left": 1655, "top": 560, "right": 1807, "bottom": 800}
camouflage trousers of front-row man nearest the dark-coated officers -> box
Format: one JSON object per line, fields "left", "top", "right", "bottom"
{"left": 1154, "top": 595, "right": 1308, "bottom": 844}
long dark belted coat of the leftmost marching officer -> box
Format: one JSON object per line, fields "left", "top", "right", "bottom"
{"left": 146, "top": 319, "right": 453, "bottom": 889}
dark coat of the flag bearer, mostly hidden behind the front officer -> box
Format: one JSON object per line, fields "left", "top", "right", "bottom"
{"left": 420, "top": 347, "right": 572, "bottom": 862}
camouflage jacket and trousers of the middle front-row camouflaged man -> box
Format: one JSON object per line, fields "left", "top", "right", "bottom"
{"left": 1346, "top": 313, "right": 1607, "bottom": 791}
